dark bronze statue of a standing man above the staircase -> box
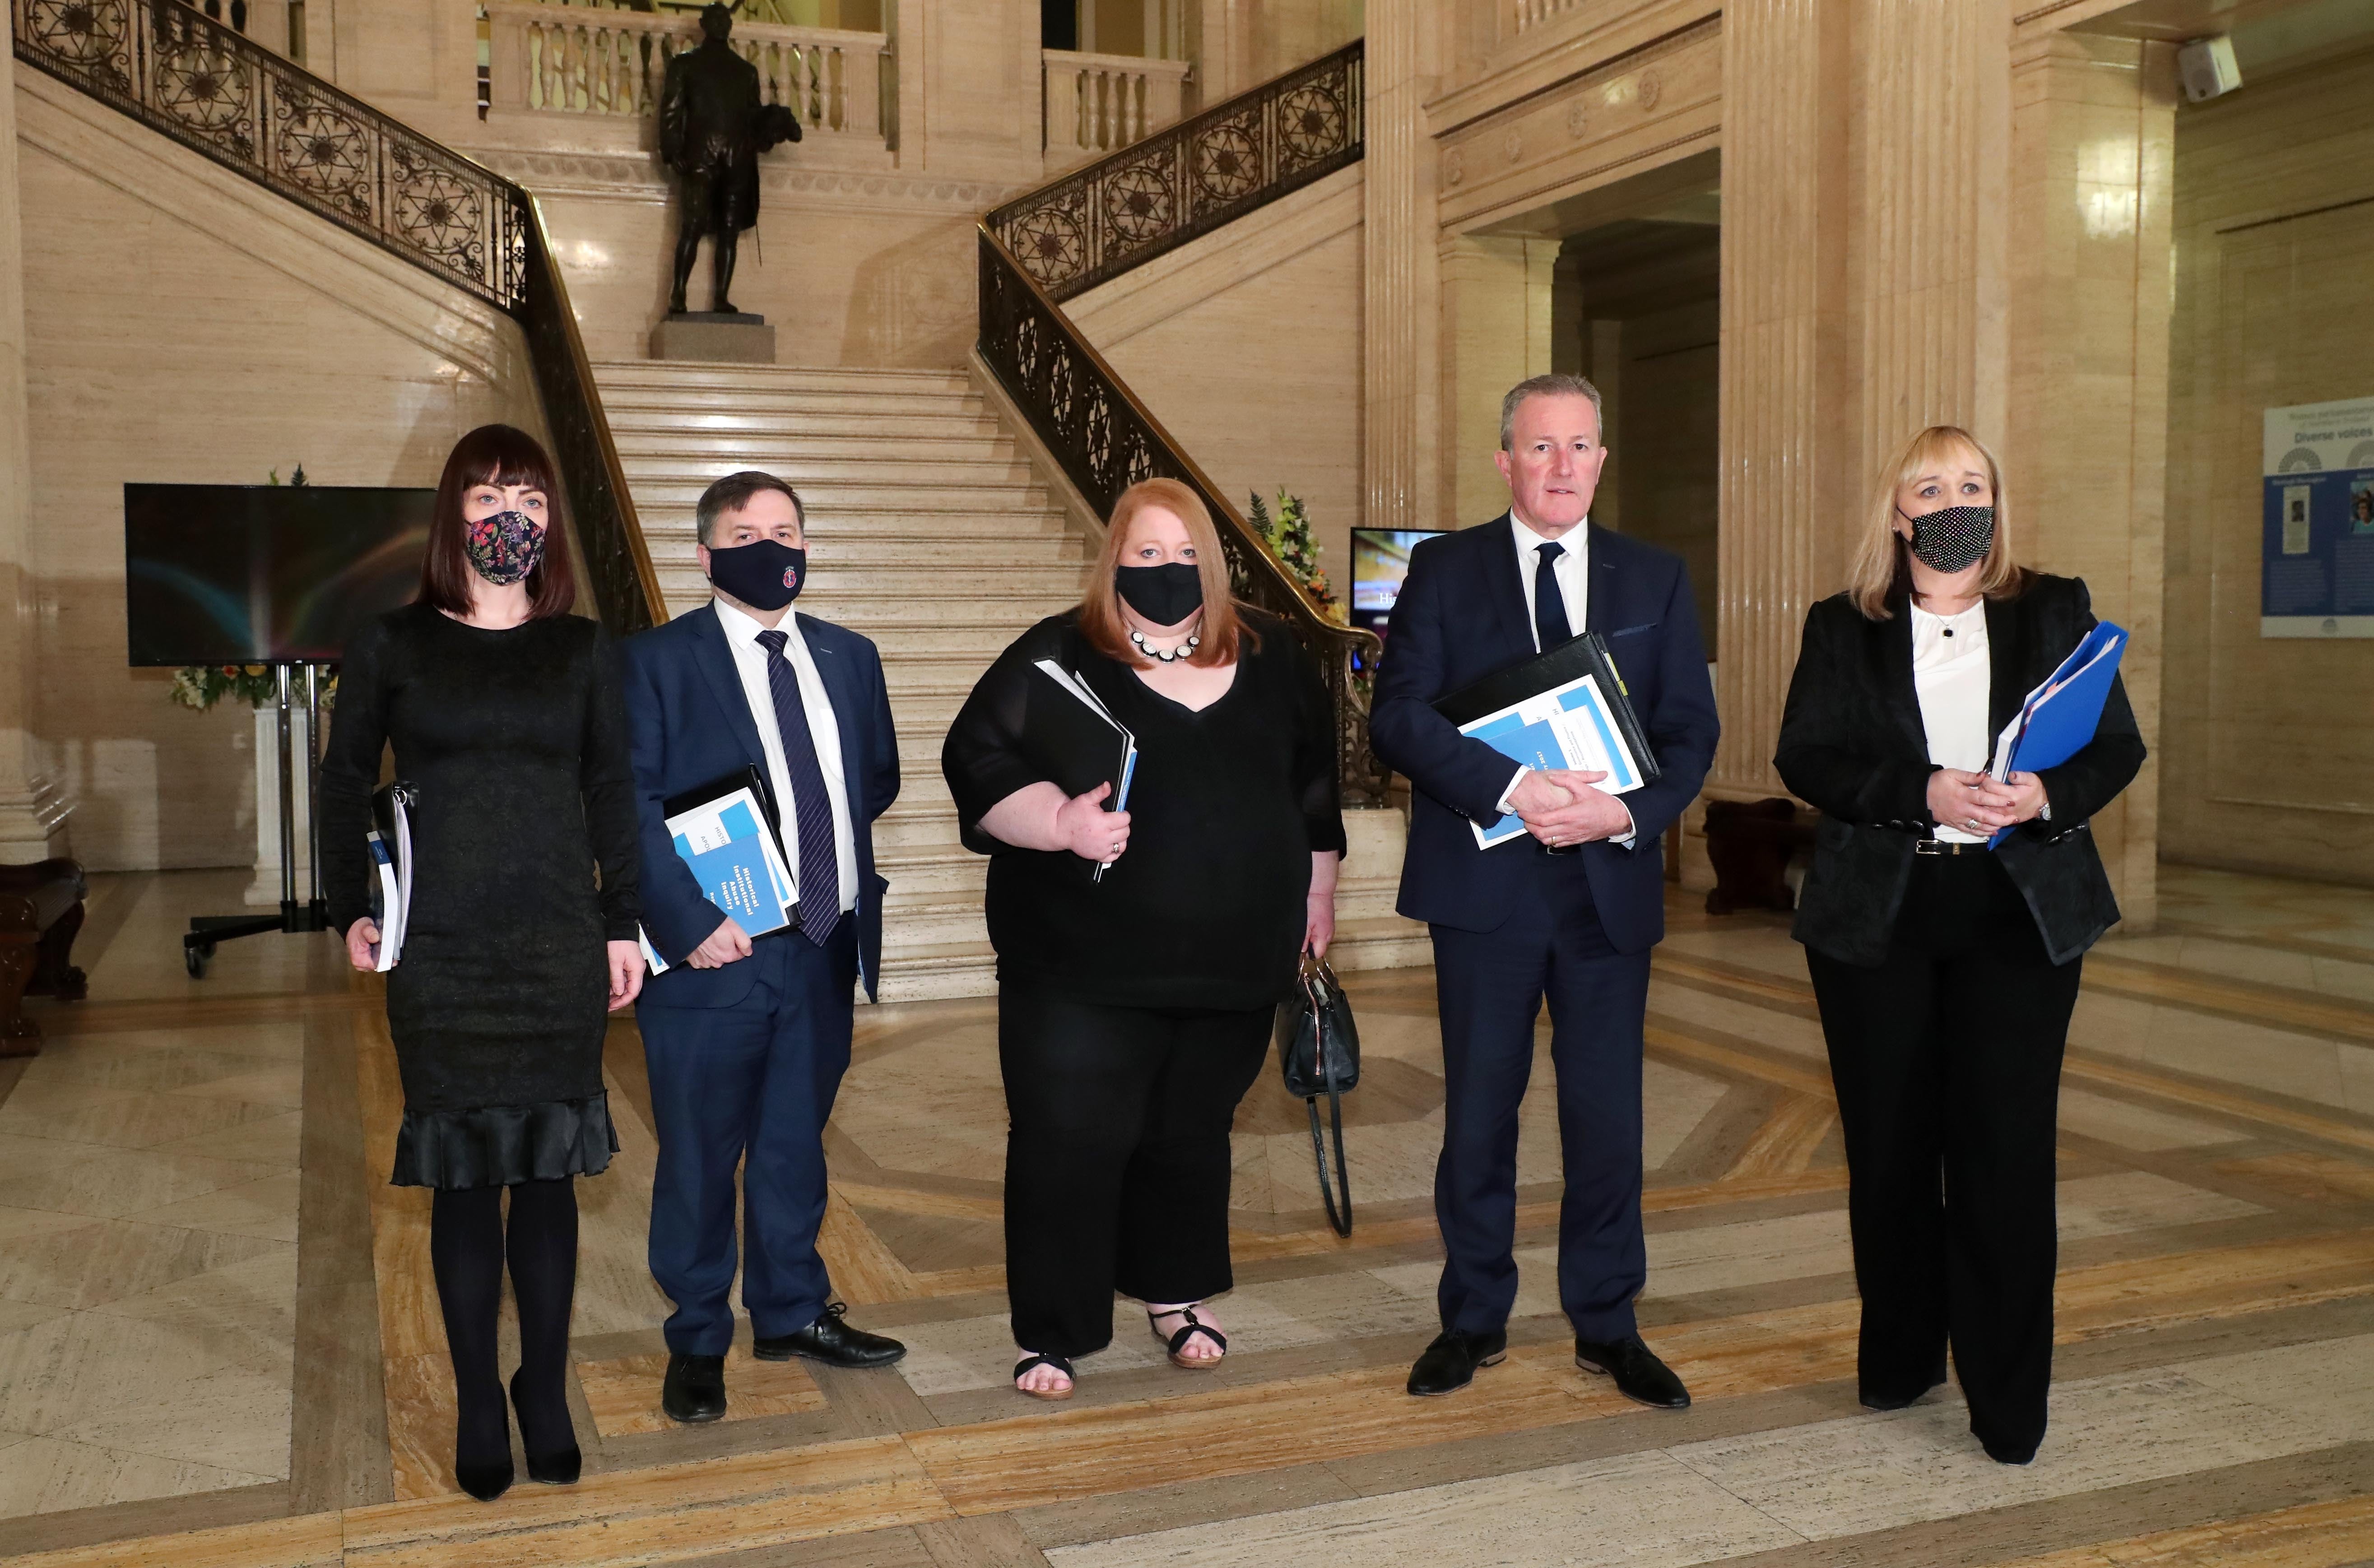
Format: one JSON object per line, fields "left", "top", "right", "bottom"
{"left": 660, "top": 5, "right": 800, "bottom": 315}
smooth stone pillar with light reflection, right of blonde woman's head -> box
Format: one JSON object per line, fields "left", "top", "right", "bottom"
{"left": 2004, "top": 33, "right": 2177, "bottom": 930}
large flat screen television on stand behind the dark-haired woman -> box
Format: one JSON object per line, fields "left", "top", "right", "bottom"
{"left": 123, "top": 484, "right": 437, "bottom": 664}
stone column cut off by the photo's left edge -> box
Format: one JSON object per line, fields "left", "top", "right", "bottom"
{"left": 0, "top": 73, "right": 66, "bottom": 863}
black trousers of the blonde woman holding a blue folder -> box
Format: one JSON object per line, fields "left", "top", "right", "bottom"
{"left": 1807, "top": 852, "right": 2082, "bottom": 1461}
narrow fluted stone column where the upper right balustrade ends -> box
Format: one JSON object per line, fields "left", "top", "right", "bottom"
{"left": 1360, "top": 0, "right": 1455, "bottom": 529}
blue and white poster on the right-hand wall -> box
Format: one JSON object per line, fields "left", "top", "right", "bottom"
{"left": 2258, "top": 399, "right": 2374, "bottom": 638}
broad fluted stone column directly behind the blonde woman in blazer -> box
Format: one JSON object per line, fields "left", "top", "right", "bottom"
{"left": 1707, "top": 0, "right": 2011, "bottom": 799}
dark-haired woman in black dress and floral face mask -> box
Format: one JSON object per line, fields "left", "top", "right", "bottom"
{"left": 321, "top": 425, "right": 643, "bottom": 1499}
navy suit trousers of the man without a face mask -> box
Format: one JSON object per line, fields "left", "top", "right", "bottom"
{"left": 1431, "top": 844, "right": 1648, "bottom": 1340}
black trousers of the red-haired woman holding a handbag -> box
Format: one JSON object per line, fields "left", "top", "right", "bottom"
{"left": 997, "top": 984, "right": 1277, "bottom": 1357}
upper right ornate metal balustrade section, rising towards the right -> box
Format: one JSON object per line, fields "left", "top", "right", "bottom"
{"left": 988, "top": 43, "right": 1360, "bottom": 301}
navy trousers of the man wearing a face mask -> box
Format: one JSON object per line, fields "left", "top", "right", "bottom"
{"left": 636, "top": 918, "right": 857, "bottom": 1355}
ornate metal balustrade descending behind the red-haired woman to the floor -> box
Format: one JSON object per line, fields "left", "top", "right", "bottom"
{"left": 980, "top": 223, "right": 1389, "bottom": 807}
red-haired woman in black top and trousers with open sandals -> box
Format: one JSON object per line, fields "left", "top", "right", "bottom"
{"left": 940, "top": 479, "right": 1344, "bottom": 1400}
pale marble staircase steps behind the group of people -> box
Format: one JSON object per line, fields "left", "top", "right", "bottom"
{"left": 594, "top": 361, "right": 1431, "bottom": 1001}
